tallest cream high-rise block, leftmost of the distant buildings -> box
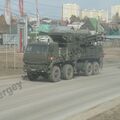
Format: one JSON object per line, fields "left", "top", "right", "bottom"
{"left": 62, "top": 4, "right": 80, "bottom": 20}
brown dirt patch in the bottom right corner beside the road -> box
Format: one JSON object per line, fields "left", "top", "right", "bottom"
{"left": 88, "top": 105, "right": 120, "bottom": 120}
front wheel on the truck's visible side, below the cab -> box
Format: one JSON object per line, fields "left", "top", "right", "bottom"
{"left": 49, "top": 66, "right": 61, "bottom": 82}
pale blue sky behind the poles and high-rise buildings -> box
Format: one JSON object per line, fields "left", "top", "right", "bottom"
{"left": 0, "top": 0, "right": 120, "bottom": 18}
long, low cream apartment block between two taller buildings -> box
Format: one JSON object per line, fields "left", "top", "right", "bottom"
{"left": 81, "top": 9, "right": 108, "bottom": 21}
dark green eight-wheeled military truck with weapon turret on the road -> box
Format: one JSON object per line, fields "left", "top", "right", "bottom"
{"left": 23, "top": 31, "right": 103, "bottom": 82}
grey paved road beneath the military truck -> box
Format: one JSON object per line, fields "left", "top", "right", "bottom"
{"left": 0, "top": 64, "right": 120, "bottom": 120}
